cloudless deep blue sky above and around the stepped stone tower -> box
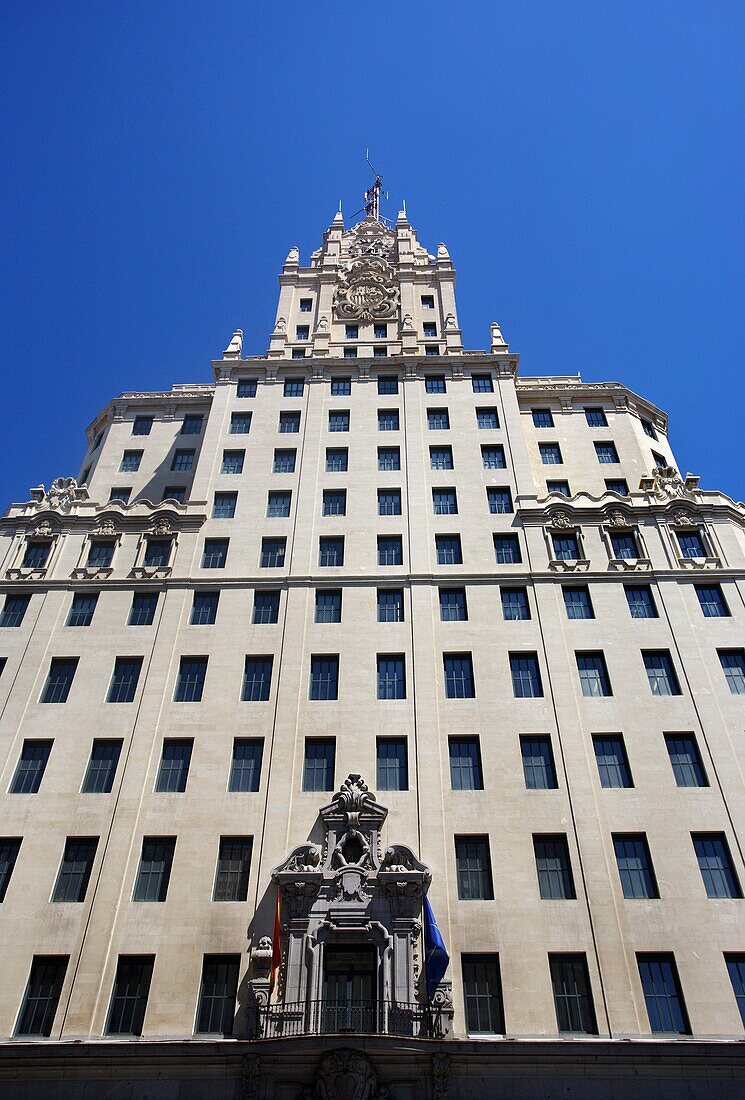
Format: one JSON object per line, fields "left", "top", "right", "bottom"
{"left": 0, "top": 0, "right": 745, "bottom": 508}
